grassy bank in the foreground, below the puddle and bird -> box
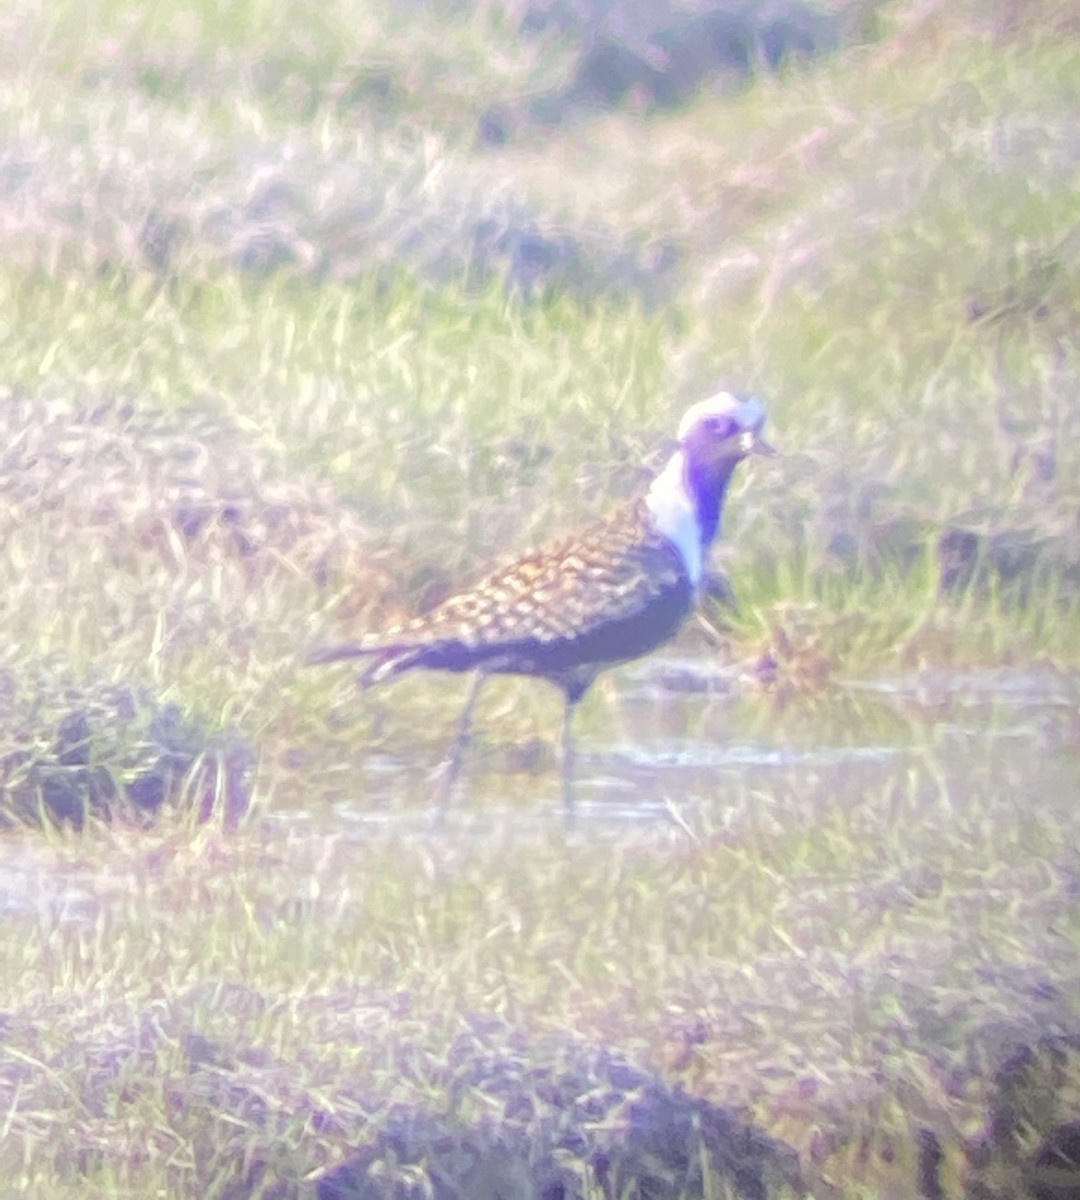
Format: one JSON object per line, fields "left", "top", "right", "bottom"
{"left": 0, "top": 705, "right": 1076, "bottom": 1198}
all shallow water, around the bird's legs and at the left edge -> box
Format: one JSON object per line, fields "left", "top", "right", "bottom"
{"left": 0, "top": 658, "right": 1080, "bottom": 920}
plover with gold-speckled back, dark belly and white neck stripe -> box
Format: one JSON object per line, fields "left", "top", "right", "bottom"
{"left": 307, "top": 391, "right": 776, "bottom": 816}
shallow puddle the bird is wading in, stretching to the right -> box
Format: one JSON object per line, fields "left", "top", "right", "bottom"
{"left": 309, "top": 659, "right": 1080, "bottom": 833}
